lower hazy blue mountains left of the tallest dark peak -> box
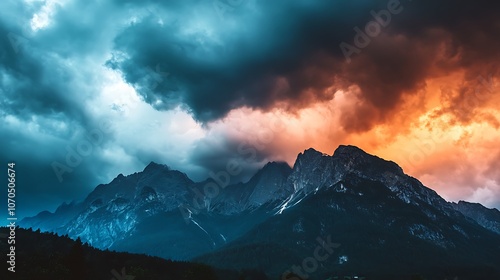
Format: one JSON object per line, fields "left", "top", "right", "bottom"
{"left": 21, "top": 162, "right": 291, "bottom": 260}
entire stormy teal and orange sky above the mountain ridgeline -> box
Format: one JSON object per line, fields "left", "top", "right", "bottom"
{"left": 0, "top": 0, "right": 500, "bottom": 218}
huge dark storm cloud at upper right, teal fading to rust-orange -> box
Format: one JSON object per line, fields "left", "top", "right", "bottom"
{"left": 109, "top": 1, "right": 500, "bottom": 131}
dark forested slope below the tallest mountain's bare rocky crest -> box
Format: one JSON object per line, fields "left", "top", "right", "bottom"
{"left": 195, "top": 175, "right": 500, "bottom": 279}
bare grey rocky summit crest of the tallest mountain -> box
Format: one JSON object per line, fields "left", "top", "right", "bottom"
{"left": 288, "top": 146, "right": 451, "bottom": 210}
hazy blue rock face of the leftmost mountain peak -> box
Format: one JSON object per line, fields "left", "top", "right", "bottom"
{"left": 23, "top": 163, "right": 194, "bottom": 248}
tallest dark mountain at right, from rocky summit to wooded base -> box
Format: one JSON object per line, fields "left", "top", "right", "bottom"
{"left": 195, "top": 146, "right": 500, "bottom": 279}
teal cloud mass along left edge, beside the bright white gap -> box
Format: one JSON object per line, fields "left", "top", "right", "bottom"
{"left": 0, "top": 1, "right": 122, "bottom": 217}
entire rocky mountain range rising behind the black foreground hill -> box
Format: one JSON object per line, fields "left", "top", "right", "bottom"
{"left": 21, "top": 146, "right": 500, "bottom": 279}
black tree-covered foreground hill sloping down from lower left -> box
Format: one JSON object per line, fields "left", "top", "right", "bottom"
{"left": 0, "top": 227, "right": 267, "bottom": 280}
